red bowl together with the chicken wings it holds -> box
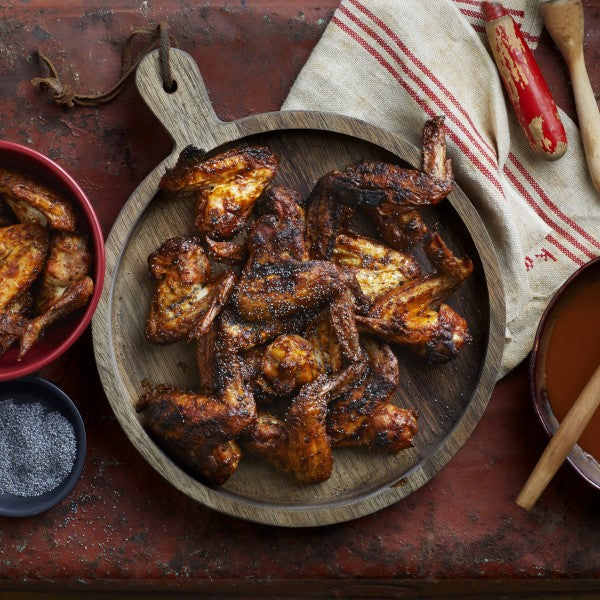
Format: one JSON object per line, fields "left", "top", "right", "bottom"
{"left": 0, "top": 141, "right": 105, "bottom": 381}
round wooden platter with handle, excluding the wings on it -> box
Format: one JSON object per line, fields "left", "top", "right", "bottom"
{"left": 93, "top": 50, "right": 504, "bottom": 527}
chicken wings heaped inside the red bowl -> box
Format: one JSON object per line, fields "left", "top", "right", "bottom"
{"left": 0, "top": 168, "right": 94, "bottom": 360}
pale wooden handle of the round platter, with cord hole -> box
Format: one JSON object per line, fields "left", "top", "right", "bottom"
{"left": 135, "top": 48, "right": 231, "bottom": 154}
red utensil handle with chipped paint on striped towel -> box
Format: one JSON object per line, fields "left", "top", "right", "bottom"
{"left": 481, "top": 2, "right": 567, "bottom": 160}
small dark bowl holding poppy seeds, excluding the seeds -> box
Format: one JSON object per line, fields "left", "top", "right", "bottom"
{"left": 0, "top": 376, "right": 86, "bottom": 517}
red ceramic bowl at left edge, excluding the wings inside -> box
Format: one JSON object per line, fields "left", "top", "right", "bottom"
{"left": 0, "top": 141, "right": 104, "bottom": 381}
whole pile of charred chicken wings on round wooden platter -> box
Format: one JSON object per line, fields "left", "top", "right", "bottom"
{"left": 137, "top": 117, "right": 473, "bottom": 485}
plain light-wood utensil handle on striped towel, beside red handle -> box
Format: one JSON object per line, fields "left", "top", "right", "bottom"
{"left": 540, "top": 0, "right": 600, "bottom": 192}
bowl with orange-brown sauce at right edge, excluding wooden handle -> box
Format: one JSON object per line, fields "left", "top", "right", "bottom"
{"left": 530, "top": 258, "right": 600, "bottom": 489}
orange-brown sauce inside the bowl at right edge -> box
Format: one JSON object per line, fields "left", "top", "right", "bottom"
{"left": 546, "top": 269, "right": 600, "bottom": 460}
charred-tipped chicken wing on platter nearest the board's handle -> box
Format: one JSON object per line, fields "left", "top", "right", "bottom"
{"left": 159, "top": 146, "right": 279, "bottom": 240}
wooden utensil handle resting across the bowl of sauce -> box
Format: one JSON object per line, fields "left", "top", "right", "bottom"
{"left": 516, "top": 365, "right": 600, "bottom": 510}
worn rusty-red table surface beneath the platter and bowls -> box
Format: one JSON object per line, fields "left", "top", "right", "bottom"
{"left": 0, "top": 0, "right": 600, "bottom": 593}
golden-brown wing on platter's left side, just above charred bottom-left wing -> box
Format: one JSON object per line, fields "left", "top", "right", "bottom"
{"left": 146, "top": 237, "right": 235, "bottom": 344}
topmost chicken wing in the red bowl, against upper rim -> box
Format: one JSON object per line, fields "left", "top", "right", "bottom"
{"left": 0, "top": 168, "right": 76, "bottom": 231}
